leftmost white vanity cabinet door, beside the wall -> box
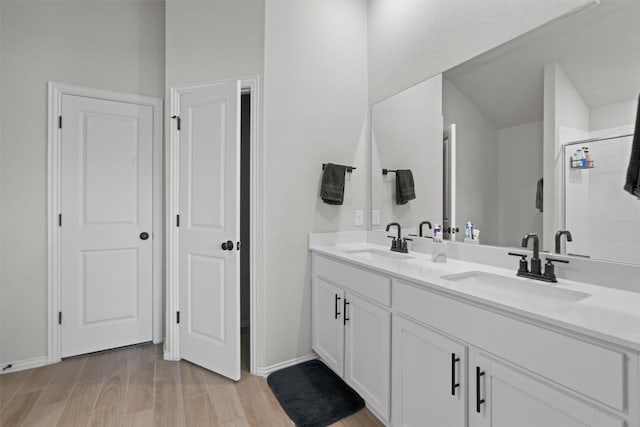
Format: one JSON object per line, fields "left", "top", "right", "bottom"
{"left": 311, "top": 277, "right": 344, "bottom": 376}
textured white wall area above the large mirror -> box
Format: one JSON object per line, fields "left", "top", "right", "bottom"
{"left": 369, "top": 0, "right": 587, "bottom": 103}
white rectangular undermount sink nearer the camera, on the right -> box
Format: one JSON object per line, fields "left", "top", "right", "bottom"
{"left": 442, "top": 271, "right": 591, "bottom": 305}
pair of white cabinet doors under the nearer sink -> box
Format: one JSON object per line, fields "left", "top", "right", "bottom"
{"left": 392, "top": 316, "right": 625, "bottom": 427}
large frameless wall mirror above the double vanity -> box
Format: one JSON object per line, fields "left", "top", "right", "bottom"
{"left": 371, "top": 1, "right": 640, "bottom": 263}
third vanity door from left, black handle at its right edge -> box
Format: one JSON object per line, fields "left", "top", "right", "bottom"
{"left": 391, "top": 316, "right": 467, "bottom": 427}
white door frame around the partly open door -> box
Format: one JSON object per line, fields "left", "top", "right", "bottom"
{"left": 169, "top": 75, "right": 264, "bottom": 374}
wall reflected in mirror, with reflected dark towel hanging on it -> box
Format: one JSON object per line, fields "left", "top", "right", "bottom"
{"left": 371, "top": 74, "right": 443, "bottom": 230}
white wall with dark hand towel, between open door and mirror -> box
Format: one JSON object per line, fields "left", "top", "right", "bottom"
{"left": 262, "top": 0, "right": 369, "bottom": 366}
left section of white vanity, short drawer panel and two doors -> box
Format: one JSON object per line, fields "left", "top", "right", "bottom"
{"left": 312, "top": 254, "right": 391, "bottom": 420}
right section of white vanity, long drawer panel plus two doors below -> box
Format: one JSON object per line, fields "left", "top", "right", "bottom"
{"left": 392, "top": 282, "right": 639, "bottom": 427}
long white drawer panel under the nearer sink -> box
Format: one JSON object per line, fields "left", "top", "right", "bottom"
{"left": 393, "top": 282, "right": 628, "bottom": 411}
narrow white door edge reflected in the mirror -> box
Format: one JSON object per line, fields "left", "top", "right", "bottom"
{"left": 442, "top": 124, "right": 464, "bottom": 240}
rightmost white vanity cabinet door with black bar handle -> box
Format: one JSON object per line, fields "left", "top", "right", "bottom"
{"left": 469, "top": 350, "right": 624, "bottom": 427}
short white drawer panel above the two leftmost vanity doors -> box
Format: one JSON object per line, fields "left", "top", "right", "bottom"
{"left": 313, "top": 254, "right": 391, "bottom": 306}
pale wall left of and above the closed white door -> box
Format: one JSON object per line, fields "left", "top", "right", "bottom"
{"left": 0, "top": 0, "right": 164, "bottom": 362}
